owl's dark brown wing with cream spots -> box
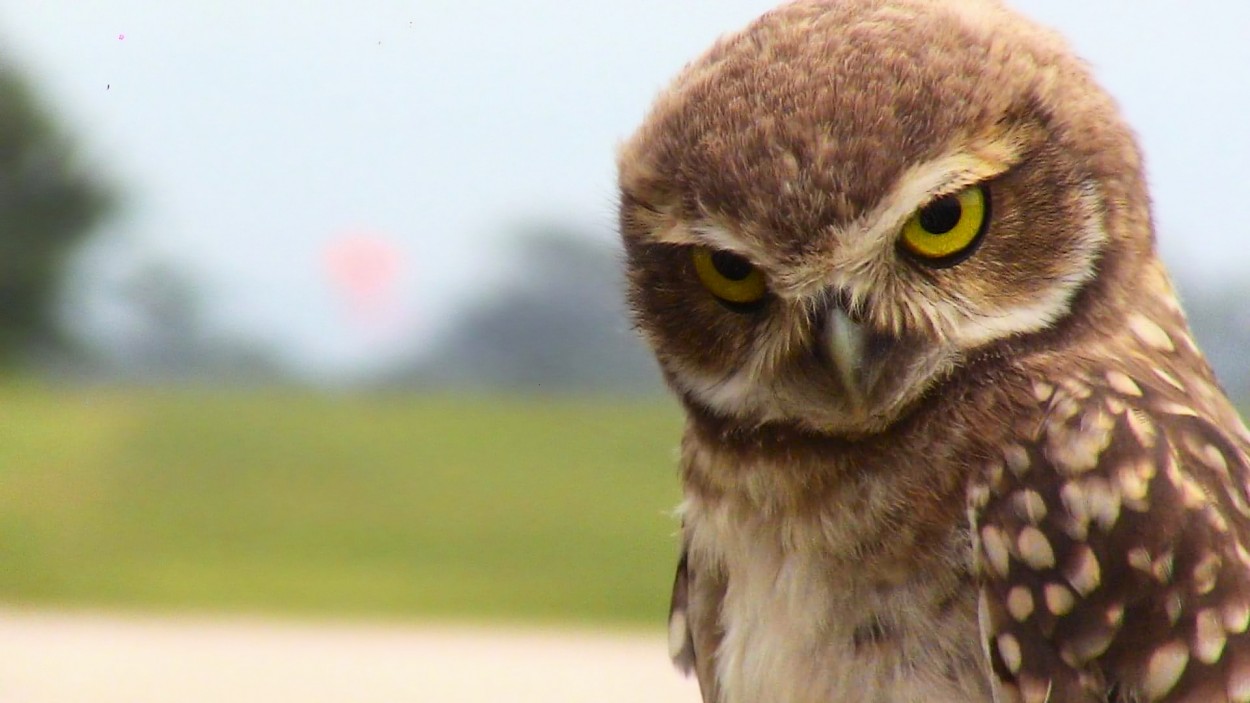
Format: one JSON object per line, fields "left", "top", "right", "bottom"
{"left": 969, "top": 370, "right": 1250, "bottom": 703}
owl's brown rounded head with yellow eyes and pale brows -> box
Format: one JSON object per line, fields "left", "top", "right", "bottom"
{"left": 619, "top": 0, "right": 1158, "bottom": 434}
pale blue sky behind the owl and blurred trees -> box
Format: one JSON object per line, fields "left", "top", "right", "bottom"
{"left": 0, "top": 0, "right": 1250, "bottom": 378}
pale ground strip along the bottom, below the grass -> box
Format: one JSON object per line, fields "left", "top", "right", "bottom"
{"left": 0, "top": 610, "right": 699, "bottom": 703}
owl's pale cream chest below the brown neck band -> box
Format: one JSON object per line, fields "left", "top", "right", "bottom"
{"left": 686, "top": 500, "right": 990, "bottom": 703}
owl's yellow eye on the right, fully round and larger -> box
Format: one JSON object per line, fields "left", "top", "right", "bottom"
{"left": 903, "top": 185, "right": 990, "bottom": 265}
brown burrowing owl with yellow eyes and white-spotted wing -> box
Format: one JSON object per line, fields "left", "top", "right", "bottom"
{"left": 620, "top": 0, "right": 1250, "bottom": 703}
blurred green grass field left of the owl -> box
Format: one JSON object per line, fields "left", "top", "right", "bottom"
{"left": 0, "top": 384, "right": 680, "bottom": 627}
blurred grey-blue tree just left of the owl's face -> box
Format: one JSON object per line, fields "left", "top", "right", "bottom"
{"left": 388, "top": 225, "right": 659, "bottom": 392}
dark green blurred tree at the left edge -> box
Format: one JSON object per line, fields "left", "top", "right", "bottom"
{"left": 0, "top": 56, "right": 109, "bottom": 365}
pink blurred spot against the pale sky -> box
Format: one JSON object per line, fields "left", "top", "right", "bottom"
{"left": 323, "top": 230, "right": 404, "bottom": 323}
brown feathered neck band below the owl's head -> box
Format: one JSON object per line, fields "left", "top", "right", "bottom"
{"left": 681, "top": 362, "right": 1030, "bottom": 537}
